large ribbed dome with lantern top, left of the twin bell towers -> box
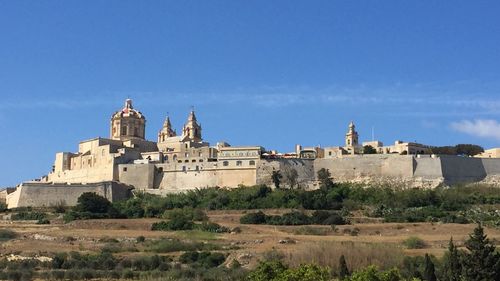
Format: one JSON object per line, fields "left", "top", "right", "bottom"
{"left": 110, "top": 99, "right": 146, "bottom": 141}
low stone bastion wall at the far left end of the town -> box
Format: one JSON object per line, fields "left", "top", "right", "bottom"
{"left": 6, "top": 182, "right": 130, "bottom": 209}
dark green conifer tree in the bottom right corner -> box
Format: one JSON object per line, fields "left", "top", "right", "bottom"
{"left": 463, "top": 225, "right": 500, "bottom": 281}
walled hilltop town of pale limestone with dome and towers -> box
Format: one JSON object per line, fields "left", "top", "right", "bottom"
{"left": 2, "top": 99, "right": 500, "bottom": 208}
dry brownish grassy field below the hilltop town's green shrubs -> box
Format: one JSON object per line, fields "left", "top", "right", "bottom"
{"left": 0, "top": 210, "right": 500, "bottom": 268}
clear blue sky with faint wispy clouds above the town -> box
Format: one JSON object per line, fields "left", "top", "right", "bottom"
{"left": 0, "top": 0, "right": 500, "bottom": 186}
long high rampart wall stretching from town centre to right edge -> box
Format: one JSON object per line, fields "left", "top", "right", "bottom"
{"left": 118, "top": 154, "right": 500, "bottom": 193}
